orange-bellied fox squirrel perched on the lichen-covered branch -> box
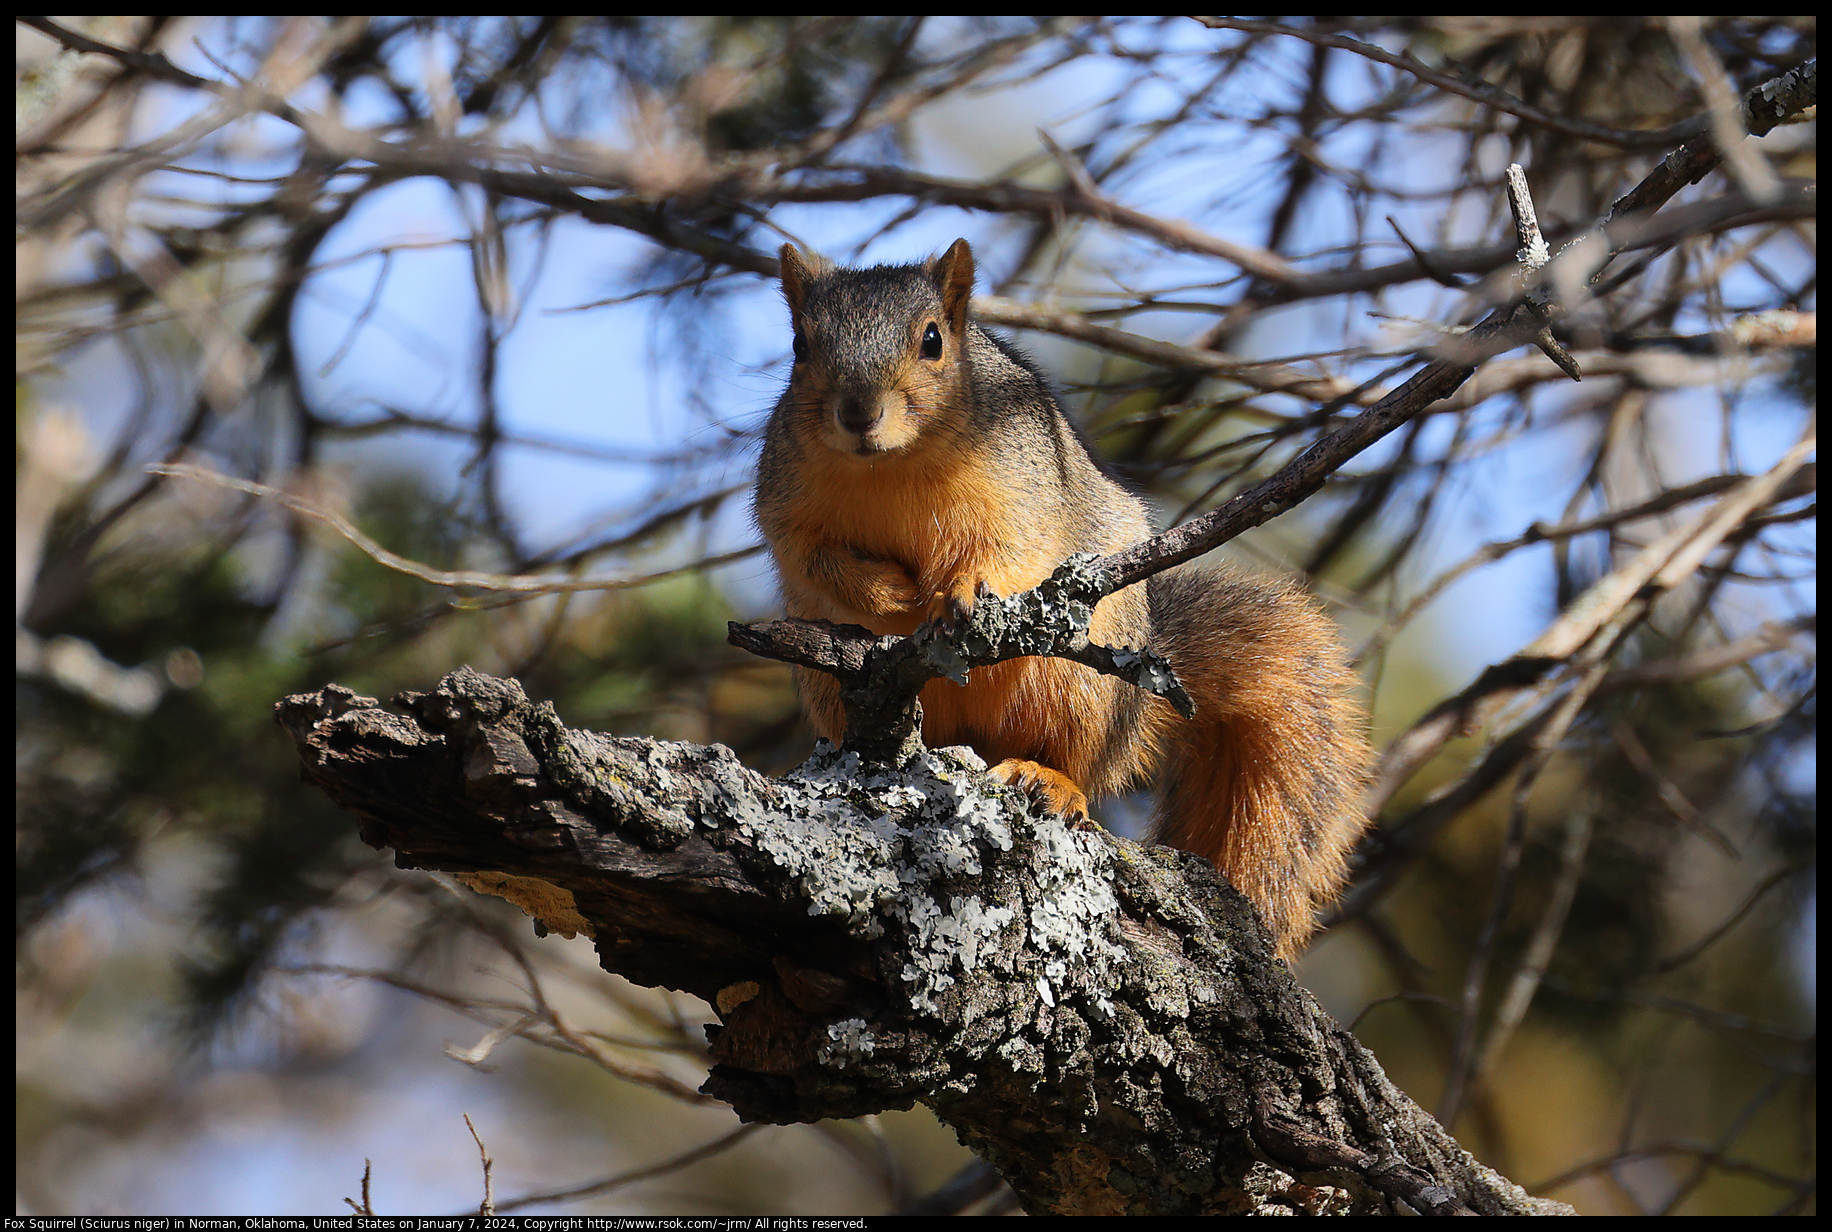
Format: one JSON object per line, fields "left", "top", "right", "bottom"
{"left": 757, "top": 240, "right": 1369, "bottom": 957}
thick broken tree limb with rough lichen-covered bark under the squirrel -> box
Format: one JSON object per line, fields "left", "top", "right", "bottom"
{"left": 277, "top": 669, "right": 1570, "bottom": 1216}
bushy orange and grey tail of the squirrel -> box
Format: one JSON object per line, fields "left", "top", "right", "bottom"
{"left": 1150, "top": 567, "right": 1369, "bottom": 959}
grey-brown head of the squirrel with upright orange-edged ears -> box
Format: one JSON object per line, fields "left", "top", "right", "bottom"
{"left": 782, "top": 240, "right": 973, "bottom": 458}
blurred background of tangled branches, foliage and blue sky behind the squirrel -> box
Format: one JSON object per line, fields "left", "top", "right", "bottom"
{"left": 15, "top": 17, "right": 1817, "bottom": 1216}
